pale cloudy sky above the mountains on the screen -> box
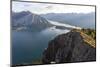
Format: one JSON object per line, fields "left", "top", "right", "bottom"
{"left": 12, "top": 2, "right": 95, "bottom": 14}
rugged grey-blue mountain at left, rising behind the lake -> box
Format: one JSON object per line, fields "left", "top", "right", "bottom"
{"left": 12, "top": 11, "right": 52, "bottom": 30}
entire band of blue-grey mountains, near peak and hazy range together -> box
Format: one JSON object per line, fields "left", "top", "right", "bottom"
{"left": 12, "top": 11, "right": 95, "bottom": 31}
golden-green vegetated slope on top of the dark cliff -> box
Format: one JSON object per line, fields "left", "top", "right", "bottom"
{"left": 71, "top": 29, "right": 96, "bottom": 48}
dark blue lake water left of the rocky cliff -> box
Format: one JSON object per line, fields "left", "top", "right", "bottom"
{"left": 12, "top": 27, "right": 69, "bottom": 64}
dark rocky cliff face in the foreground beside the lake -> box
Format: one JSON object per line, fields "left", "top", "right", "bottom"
{"left": 42, "top": 32, "right": 96, "bottom": 64}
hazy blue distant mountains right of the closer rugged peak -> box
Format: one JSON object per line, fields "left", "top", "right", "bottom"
{"left": 41, "top": 12, "right": 95, "bottom": 29}
